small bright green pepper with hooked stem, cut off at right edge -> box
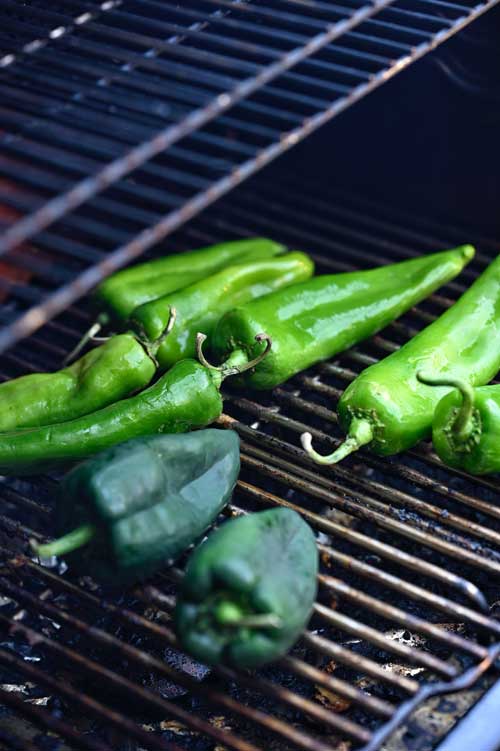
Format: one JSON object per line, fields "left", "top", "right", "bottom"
{"left": 417, "top": 373, "right": 500, "bottom": 475}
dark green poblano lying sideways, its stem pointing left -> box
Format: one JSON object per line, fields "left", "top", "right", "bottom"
{"left": 32, "top": 430, "right": 240, "bottom": 584}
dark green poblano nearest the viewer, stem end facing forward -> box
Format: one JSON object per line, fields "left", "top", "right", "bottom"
{"left": 175, "top": 508, "right": 318, "bottom": 668}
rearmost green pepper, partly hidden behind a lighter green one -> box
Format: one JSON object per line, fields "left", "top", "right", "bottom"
{"left": 94, "top": 237, "right": 285, "bottom": 322}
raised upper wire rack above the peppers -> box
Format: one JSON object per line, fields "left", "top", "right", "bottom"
{"left": 0, "top": 0, "right": 498, "bottom": 351}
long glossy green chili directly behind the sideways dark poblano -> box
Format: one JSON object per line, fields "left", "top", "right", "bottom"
{"left": 0, "top": 360, "right": 222, "bottom": 475}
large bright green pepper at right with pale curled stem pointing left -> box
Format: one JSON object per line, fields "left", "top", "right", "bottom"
{"left": 303, "top": 256, "right": 500, "bottom": 464}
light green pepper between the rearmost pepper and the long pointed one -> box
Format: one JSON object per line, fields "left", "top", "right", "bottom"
{"left": 131, "top": 252, "right": 314, "bottom": 370}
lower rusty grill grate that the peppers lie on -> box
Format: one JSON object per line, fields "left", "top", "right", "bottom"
{"left": 0, "top": 172, "right": 500, "bottom": 751}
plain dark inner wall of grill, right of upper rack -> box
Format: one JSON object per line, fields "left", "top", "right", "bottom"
{"left": 276, "top": 7, "right": 500, "bottom": 238}
